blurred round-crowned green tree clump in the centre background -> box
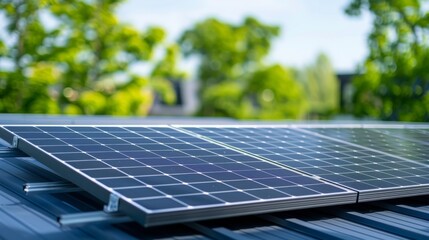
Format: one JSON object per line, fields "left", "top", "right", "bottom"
{"left": 180, "top": 17, "right": 306, "bottom": 119}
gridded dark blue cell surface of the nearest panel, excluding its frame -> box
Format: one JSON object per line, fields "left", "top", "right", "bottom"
{"left": 0, "top": 126, "right": 352, "bottom": 222}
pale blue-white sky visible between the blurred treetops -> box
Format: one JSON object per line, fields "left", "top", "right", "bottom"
{"left": 117, "top": 0, "right": 371, "bottom": 73}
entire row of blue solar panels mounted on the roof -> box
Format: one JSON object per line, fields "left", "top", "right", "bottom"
{"left": 0, "top": 126, "right": 429, "bottom": 226}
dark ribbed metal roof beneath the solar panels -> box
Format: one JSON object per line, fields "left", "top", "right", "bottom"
{"left": 0, "top": 115, "right": 429, "bottom": 239}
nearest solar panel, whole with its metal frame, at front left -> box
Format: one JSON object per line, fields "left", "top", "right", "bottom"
{"left": 0, "top": 126, "right": 357, "bottom": 226}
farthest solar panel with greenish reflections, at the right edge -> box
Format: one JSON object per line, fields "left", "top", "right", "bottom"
{"left": 308, "top": 127, "right": 429, "bottom": 165}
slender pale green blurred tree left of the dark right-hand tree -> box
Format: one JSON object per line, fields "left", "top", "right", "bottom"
{"left": 297, "top": 54, "right": 340, "bottom": 119}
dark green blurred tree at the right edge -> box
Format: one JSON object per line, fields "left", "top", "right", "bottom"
{"left": 346, "top": 0, "right": 429, "bottom": 121}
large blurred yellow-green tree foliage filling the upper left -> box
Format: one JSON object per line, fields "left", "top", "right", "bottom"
{"left": 0, "top": 0, "right": 177, "bottom": 115}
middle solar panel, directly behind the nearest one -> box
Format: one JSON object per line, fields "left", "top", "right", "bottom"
{"left": 183, "top": 126, "right": 429, "bottom": 201}
